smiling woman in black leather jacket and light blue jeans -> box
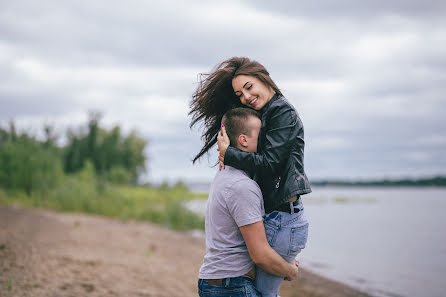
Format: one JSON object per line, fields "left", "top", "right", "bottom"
{"left": 189, "top": 57, "right": 311, "bottom": 296}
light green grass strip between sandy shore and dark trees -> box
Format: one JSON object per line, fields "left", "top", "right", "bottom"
{"left": 0, "top": 176, "right": 207, "bottom": 230}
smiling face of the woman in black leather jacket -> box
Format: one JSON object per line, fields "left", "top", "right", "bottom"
{"left": 232, "top": 75, "right": 275, "bottom": 110}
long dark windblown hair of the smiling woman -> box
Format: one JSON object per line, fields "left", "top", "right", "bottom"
{"left": 189, "top": 57, "right": 282, "bottom": 163}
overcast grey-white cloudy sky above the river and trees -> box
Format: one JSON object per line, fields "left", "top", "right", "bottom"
{"left": 0, "top": 0, "right": 446, "bottom": 181}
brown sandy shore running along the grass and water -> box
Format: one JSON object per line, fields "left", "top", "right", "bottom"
{"left": 0, "top": 206, "right": 368, "bottom": 297}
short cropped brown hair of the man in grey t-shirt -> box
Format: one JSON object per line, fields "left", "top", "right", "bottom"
{"left": 221, "top": 107, "right": 260, "bottom": 146}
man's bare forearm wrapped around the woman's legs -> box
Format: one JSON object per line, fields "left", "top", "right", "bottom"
{"left": 240, "top": 221, "right": 298, "bottom": 280}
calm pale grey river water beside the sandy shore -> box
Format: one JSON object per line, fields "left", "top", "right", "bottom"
{"left": 189, "top": 187, "right": 446, "bottom": 297}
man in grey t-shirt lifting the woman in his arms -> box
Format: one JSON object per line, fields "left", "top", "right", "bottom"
{"left": 198, "top": 108, "right": 298, "bottom": 297}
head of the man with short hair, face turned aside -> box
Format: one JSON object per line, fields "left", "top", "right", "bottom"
{"left": 221, "top": 107, "right": 262, "bottom": 152}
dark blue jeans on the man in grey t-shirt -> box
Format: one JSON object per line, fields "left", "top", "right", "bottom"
{"left": 198, "top": 276, "right": 262, "bottom": 297}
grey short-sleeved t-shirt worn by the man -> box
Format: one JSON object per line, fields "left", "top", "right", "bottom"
{"left": 198, "top": 166, "right": 265, "bottom": 279}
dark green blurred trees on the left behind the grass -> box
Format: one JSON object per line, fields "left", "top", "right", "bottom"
{"left": 0, "top": 113, "right": 148, "bottom": 195}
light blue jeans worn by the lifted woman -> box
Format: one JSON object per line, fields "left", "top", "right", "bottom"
{"left": 256, "top": 202, "right": 308, "bottom": 297}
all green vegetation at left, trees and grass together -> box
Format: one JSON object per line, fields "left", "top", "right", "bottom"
{"left": 0, "top": 116, "right": 204, "bottom": 230}
